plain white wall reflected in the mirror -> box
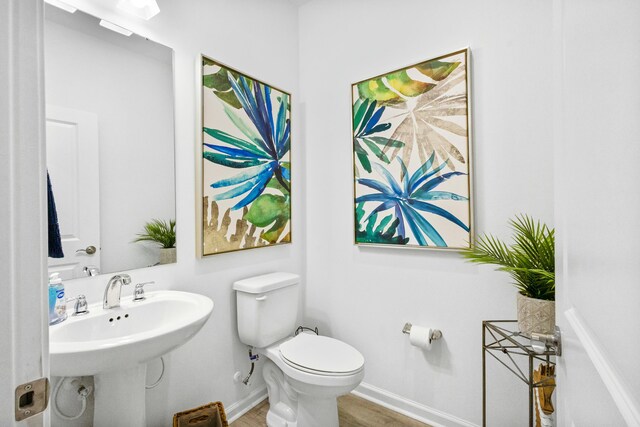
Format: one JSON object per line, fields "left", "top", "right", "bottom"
{"left": 45, "top": 13, "right": 175, "bottom": 273}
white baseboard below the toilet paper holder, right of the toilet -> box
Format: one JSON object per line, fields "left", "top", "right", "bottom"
{"left": 352, "top": 383, "right": 478, "bottom": 427}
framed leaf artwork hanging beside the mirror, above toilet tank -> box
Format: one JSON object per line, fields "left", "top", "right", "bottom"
{"left": 198, "top": 56, "right": 291, "bottom": 256}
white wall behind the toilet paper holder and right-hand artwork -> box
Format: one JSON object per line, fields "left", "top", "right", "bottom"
{"left": 299, "top": 0, "right": 553, "bottom": 426}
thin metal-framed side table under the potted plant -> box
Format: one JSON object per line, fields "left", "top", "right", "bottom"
{"left": 482, "top": 320, "right": 560, "bottom": 427}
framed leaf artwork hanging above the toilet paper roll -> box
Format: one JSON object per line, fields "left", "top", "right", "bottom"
{"left": 351, "top": 49, "right": 473, "bottom": 250}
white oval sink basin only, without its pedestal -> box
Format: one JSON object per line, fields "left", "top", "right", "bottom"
{"left": 49, "top": 291, "right": 213, "bottom": 376}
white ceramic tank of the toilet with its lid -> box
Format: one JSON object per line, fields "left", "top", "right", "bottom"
{"left": 233, "top": 273, "right": 300, "bottom": 348}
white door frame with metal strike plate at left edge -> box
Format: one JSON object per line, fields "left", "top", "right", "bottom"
{"left": 0, "top": 0, "right": 49, "bottom": 427}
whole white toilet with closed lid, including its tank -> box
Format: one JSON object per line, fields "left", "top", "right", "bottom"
{"left": 233, "top": 273, "right": 364, "bottom": 427}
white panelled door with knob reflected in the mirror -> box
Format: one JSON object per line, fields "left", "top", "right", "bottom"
{"left": 47, "top": 105, "right": 100, "bottom": 280}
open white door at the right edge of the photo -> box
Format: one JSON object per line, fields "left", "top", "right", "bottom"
{"left": 556, "top": 0, "right": 640, "bottom": 427}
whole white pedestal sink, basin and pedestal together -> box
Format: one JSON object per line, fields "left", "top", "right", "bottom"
{"left": 49, "top": 291, "right": 213, "bottom": 427}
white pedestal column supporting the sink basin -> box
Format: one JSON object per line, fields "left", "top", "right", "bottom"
{"left": 93, "top": 364, "right": 147, "bottom": 427}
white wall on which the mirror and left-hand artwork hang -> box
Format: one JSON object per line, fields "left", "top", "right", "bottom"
{"left": 49, "top": 0, "right": 305, "bottom": 427}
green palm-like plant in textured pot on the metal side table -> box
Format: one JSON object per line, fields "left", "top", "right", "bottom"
{"left": 463, "top": 215, "right": 556, "bottom": 336}
